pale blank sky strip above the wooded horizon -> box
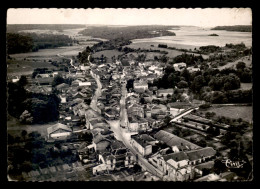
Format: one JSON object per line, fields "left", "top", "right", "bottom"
{"left": 7, "top": 8, "right": 252, "bottom": 27}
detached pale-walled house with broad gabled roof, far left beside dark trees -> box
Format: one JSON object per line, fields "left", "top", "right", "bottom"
{"left": 47, "top": 123, "right": 72, "bottom": 140}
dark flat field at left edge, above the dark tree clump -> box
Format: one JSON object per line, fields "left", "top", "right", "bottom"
{"left": 7, "top": 57, "right": 56, "bottom": 75}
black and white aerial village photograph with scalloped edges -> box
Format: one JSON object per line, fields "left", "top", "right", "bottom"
{"left": 4, "top": 7, "right": 254, "bottom": 182}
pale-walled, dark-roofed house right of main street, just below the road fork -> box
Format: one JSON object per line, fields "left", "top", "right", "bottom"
{"left": 130, "top": 134, "right": 152, "bottom": 156}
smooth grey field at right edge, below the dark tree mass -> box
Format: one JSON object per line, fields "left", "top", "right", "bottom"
{"left": 207, "top": 105, "right": 253, "bottom": 122}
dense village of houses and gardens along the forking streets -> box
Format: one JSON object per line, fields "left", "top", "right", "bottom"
{"left": 6, "top": 44, "right": 250, "bottom": 181}
